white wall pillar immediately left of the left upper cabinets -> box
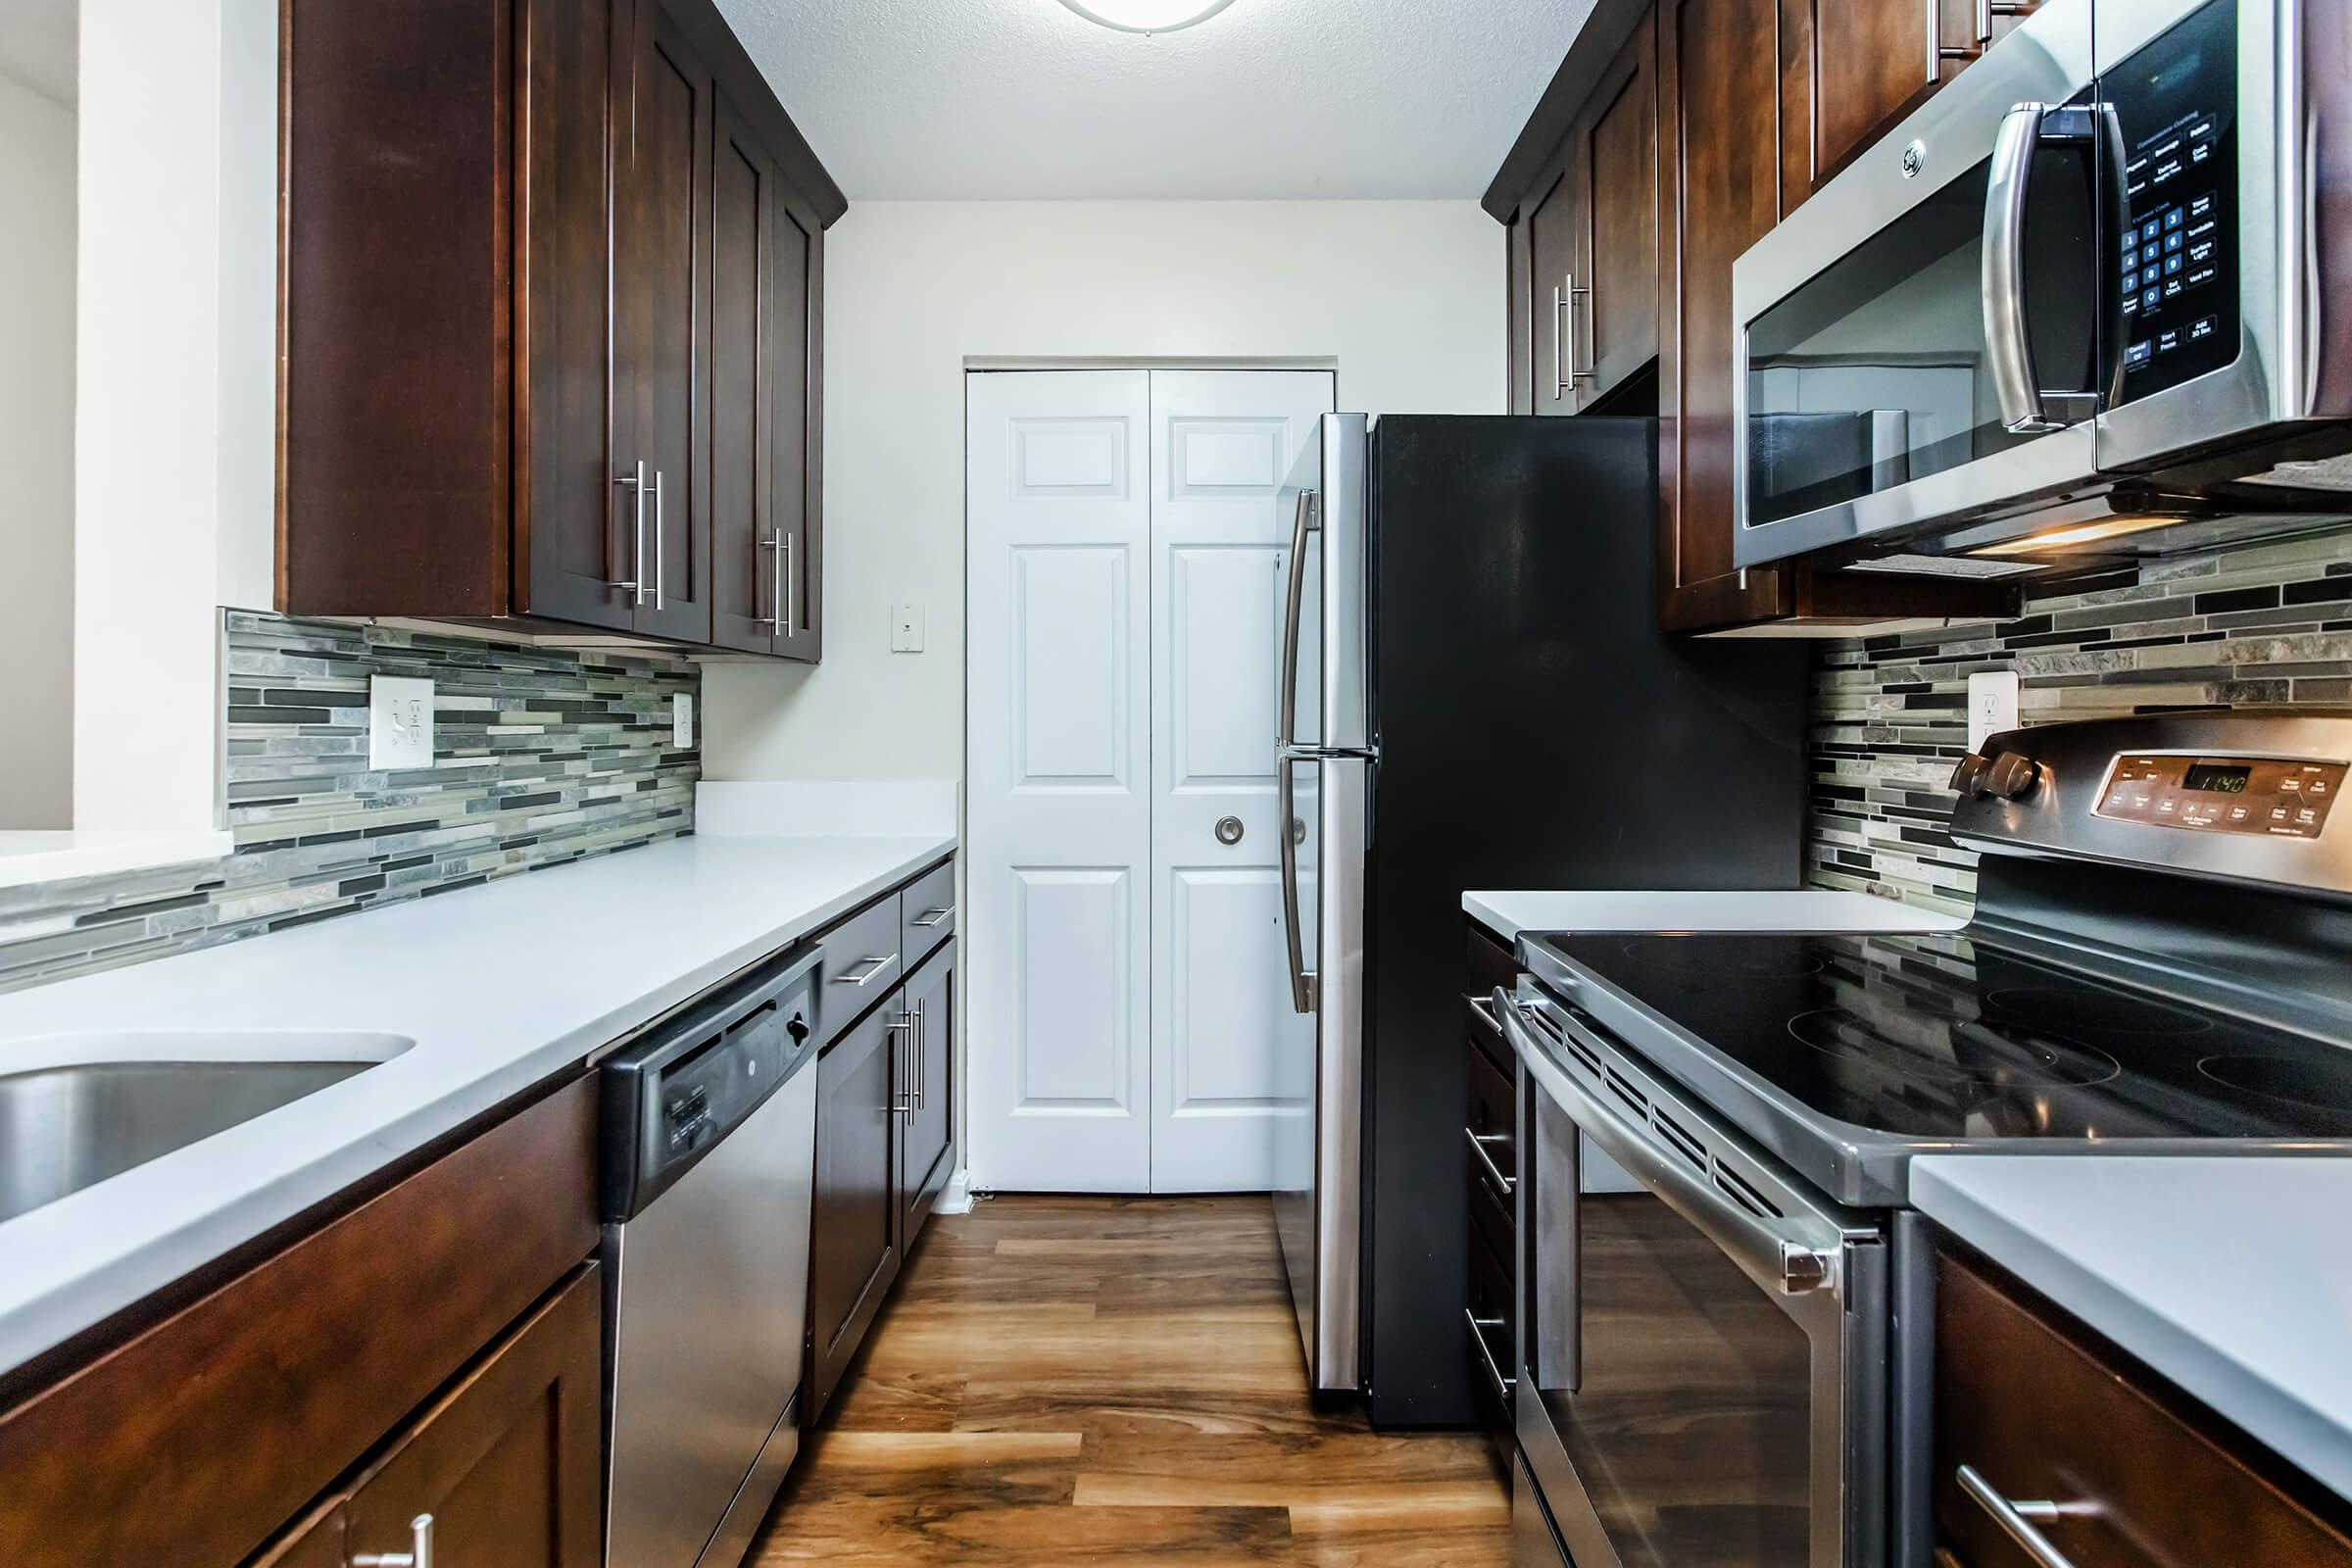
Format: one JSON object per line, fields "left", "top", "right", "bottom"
{"left": 73, "top": 0, "right": 277, "bottom": 830}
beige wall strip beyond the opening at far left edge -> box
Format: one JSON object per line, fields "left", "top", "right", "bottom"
{"left": 0, "top": 75, "right": 73, "bottom": 830}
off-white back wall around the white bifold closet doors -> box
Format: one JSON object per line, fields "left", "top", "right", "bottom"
{"left": 704, "top": 202, "right": 1507, "bottom": 778}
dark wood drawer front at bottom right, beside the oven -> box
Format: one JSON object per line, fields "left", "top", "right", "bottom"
{"left": 1936, "top": 1255, "right": 2352, "bottom": 1568}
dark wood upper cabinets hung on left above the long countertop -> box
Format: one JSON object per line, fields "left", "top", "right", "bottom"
{"left": 277, "top": 0, "right": 847, "bottom": 659}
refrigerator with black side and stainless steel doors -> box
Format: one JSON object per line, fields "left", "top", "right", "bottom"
{"left": 1272, "top": 414, "right": 1811, "bottom": 1427}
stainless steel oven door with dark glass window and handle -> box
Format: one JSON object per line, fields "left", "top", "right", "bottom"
{"left": 1494, "top": 980, "right": 1886, "bottom": 1568}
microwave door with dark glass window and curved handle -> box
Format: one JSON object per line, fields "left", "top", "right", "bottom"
{"left": 1731, "top": 5, "right": 2119, "bottom": 569}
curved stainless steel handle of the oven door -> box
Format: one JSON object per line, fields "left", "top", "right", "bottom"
{"left": 1494, "top": 987, "right": 1844, "bottom": 1296}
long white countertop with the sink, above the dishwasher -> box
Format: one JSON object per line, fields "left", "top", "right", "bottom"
{"left": 0, "top": 827, "right": 955, "bottom": 1368}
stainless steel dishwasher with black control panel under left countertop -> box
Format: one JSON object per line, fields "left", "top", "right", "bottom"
{"left": 600, "top": 948, "right": 821, "bottom": 1568}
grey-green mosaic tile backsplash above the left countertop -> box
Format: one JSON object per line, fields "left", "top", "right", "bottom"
{"left": 0, "top": 612, "right": 701, "bottom": 990}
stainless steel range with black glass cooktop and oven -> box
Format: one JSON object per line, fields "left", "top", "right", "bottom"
{"left": 1495, "top": 712, "right": 2352, "bottom": 1568}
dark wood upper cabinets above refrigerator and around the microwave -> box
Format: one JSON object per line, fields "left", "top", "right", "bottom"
{"left": 1484, "top": 0, "right": 2018, "bottom": 637}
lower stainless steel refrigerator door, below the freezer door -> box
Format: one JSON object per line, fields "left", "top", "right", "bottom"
{"left": 1272, "top": 757, "right": 1371, "bottom": 1390}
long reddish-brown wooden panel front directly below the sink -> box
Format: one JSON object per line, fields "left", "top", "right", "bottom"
{"left": 0, "top": 1079, "right": 598, "bottom": 1568}
